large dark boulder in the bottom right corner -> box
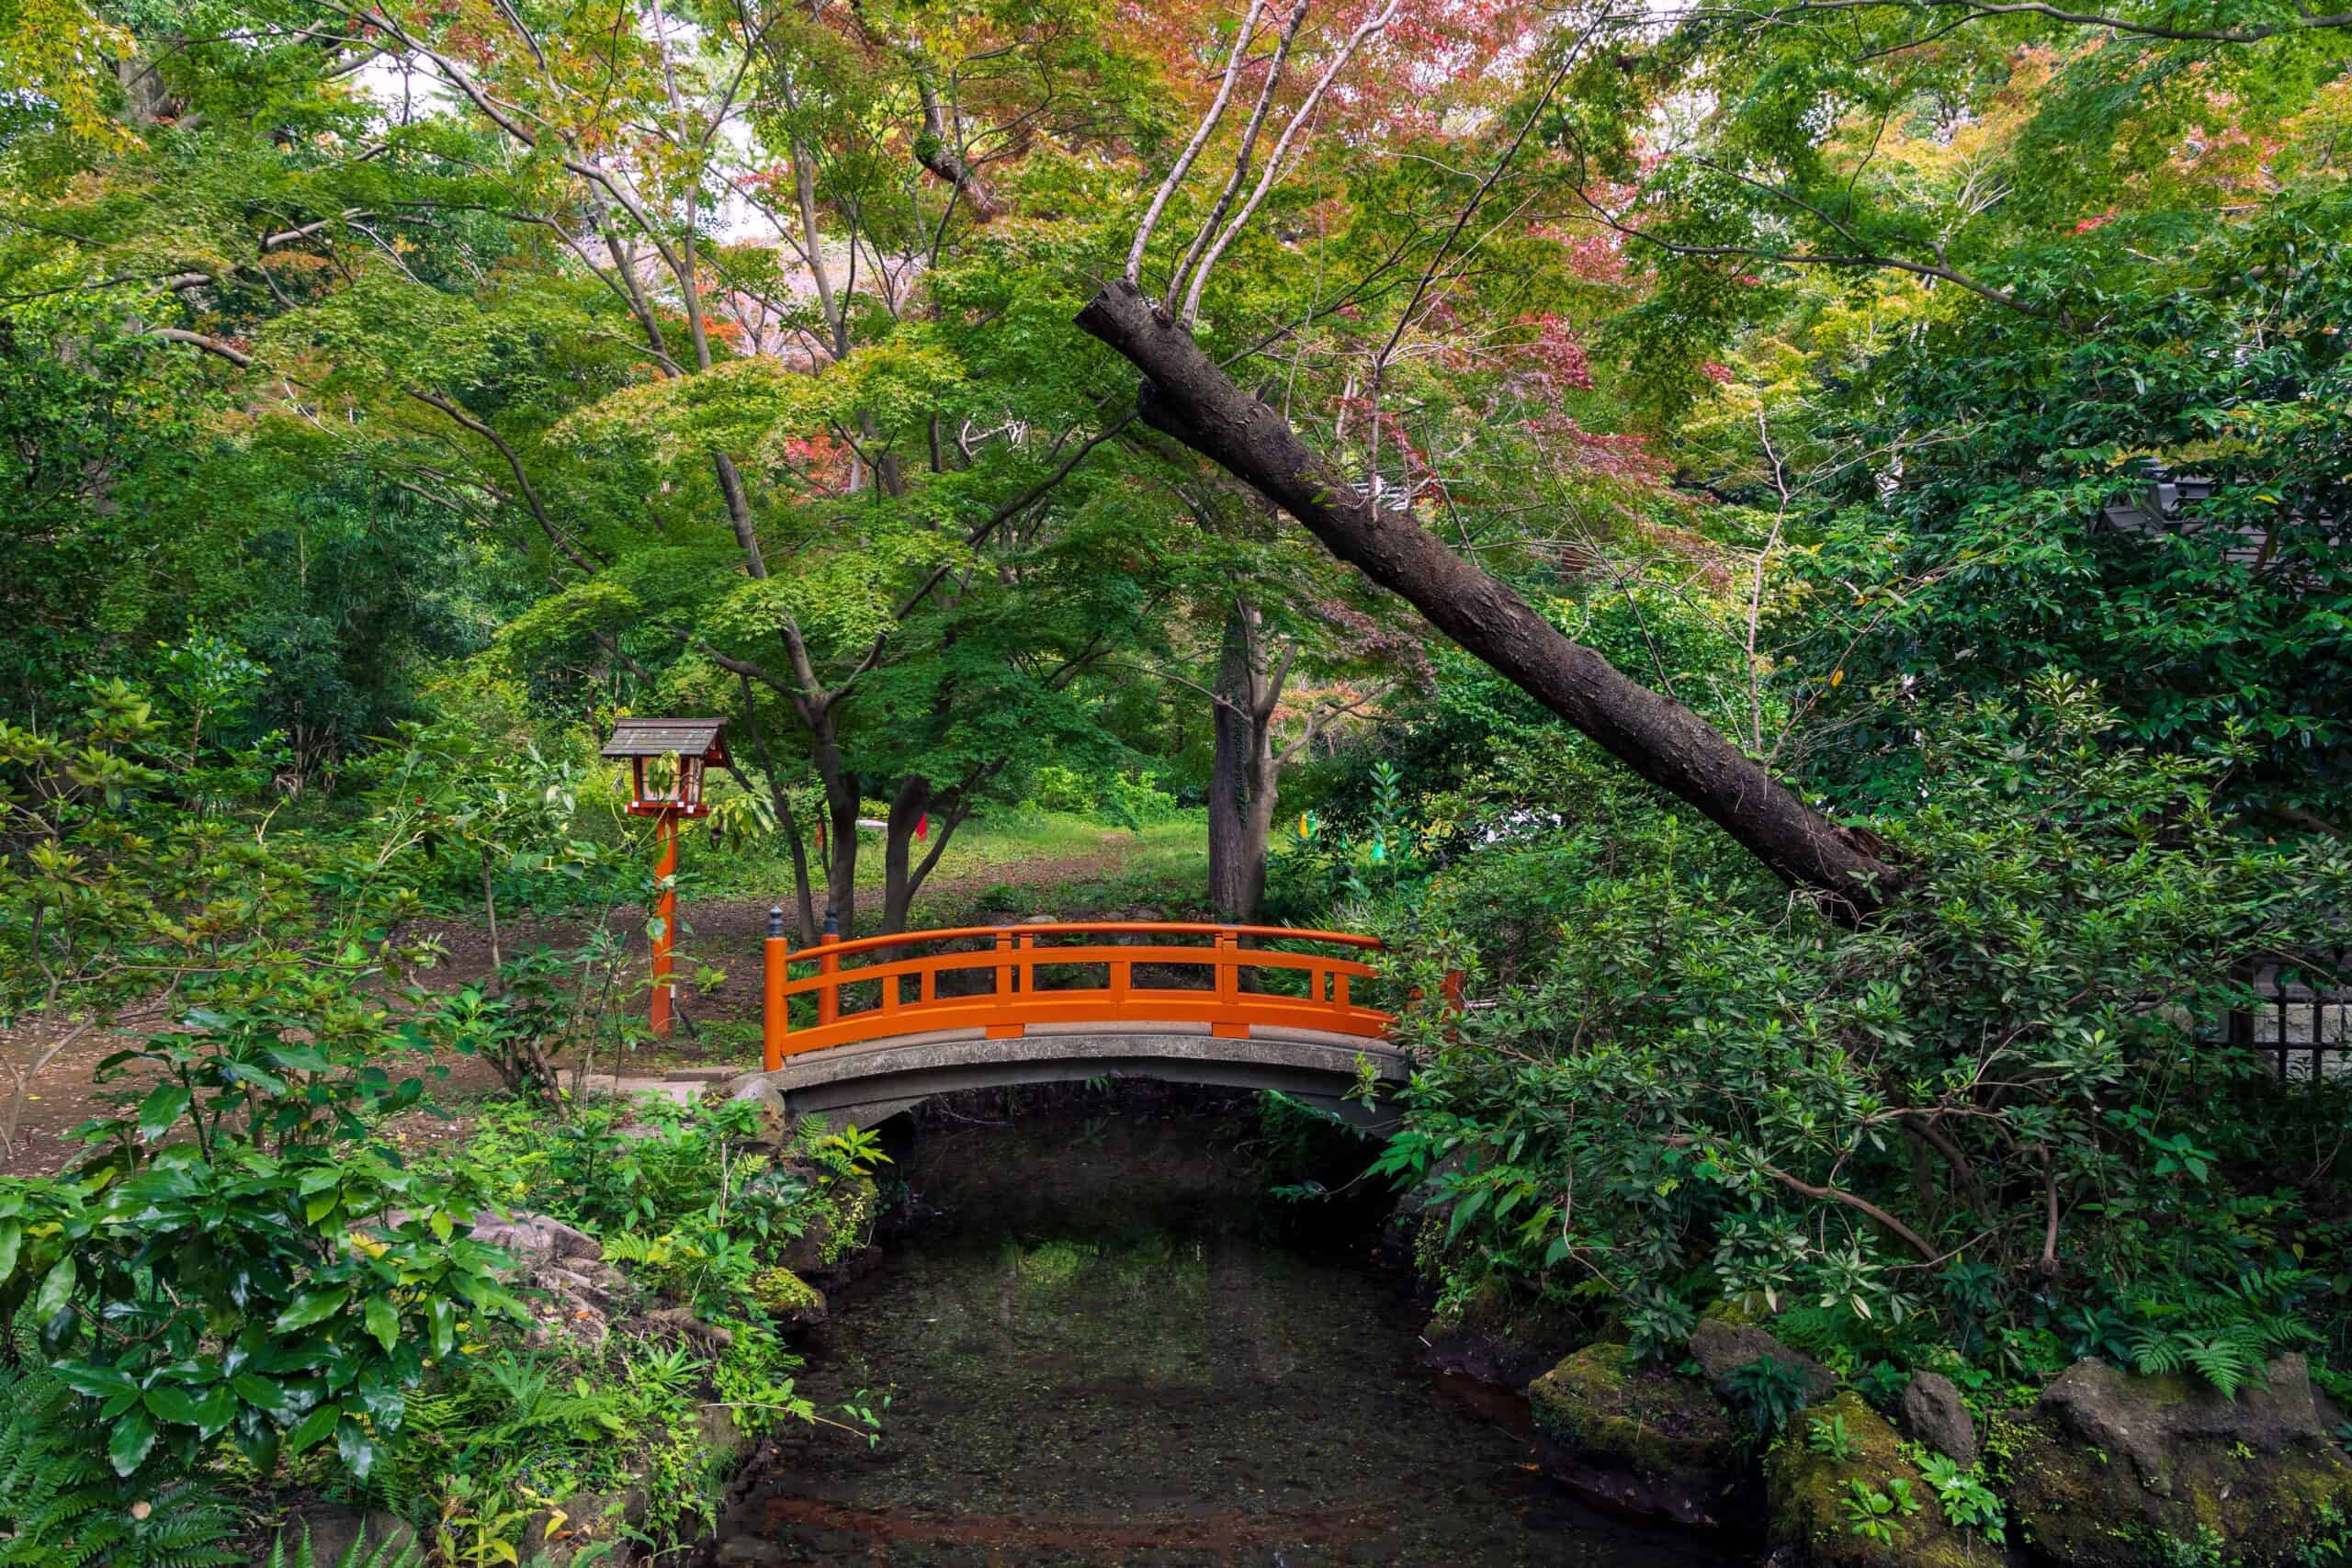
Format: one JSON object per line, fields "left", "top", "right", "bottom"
{"left": 2002, "top": 1357, "right": 2352, "bottom": 1568}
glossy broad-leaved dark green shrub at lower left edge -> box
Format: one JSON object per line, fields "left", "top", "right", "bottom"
{"left": 0, "top": 1001, "right": 522, "bottom": 1476}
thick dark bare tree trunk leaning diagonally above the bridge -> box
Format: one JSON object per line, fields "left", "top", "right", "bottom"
{"left": 1077, "top": 277, "right": 1895, "bottom": 919}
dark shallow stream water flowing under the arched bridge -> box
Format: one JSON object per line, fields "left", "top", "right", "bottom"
{"left": 718, "top": 1112, "right": 1743, "bottom": 1568}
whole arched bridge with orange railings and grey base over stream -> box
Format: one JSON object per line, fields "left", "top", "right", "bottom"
{"left": 764, "top": 909, "right": 1411, "bottom": 1126}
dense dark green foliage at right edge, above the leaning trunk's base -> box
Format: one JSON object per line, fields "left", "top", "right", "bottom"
{"left": 1781, "top": 179, "right": 2352, "bottom": 829}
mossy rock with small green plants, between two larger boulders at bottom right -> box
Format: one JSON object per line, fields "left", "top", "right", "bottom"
{"left": 1764, "top": 1389, "right": 2002, "bottom": 1568}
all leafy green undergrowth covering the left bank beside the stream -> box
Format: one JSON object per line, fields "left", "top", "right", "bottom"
{"left": 0, "top": 1058, "right": 882, "bottom": 1568}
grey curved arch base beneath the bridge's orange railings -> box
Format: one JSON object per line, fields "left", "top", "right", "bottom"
{"left": 755, "top": 1022, "right": 1411, "bottom": 1131}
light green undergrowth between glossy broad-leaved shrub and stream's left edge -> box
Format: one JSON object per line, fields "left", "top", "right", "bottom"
{"left": 329, "top": 1100, "right": 879, "bottom": 1563}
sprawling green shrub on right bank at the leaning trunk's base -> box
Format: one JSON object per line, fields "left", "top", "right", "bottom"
{"left": 1385, "top": 680, "right": 2352, "bottom": 1387}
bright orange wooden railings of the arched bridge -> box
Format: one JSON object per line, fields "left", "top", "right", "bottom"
{"left": 764, "top": 915, "right": 1390, "bottom": 1069}
